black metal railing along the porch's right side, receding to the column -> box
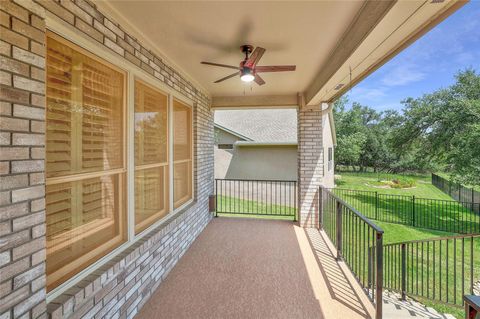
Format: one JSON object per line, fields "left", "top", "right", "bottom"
{"left": 319, "top": 187, "right": 384, "bottom": 319}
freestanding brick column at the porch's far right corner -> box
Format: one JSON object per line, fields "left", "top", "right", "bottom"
{"left": 297, "top": 106, "right": 324, "bottom": 228}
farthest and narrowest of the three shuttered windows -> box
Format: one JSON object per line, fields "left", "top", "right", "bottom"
{"left": 173, "top": 99, "right": 192, "bottom": 208}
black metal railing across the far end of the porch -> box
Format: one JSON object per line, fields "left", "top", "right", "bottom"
{"left": 215, "top": 179, "right": 297, "bottom": 220}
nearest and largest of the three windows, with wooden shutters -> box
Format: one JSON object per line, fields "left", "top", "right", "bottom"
{"left": 46, "top": 33, "right": 126, "bottom": 290}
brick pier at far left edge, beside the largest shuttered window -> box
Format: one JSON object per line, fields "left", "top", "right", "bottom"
{"left": 0, "top": 0, "right": 46, "bottom": 318}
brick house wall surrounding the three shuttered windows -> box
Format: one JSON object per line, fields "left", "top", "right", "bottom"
{"left": 0, "top": 0, "right": 214, "bottom": 319}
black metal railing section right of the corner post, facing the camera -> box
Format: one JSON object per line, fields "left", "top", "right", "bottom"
{"left": 383, "top": 234, "right": 480, "bottom": 306}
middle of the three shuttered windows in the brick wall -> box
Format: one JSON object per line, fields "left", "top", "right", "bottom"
{"left": 135, "top": 80, "right": 169, "bottom": 233}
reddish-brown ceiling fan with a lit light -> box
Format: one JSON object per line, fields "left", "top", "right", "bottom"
{"left": 200, "top": 45, "right": 296, "bottom": 85}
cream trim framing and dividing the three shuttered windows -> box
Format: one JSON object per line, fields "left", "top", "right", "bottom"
{"left": 45, "top": 12, "right": 196, "bottom": 303}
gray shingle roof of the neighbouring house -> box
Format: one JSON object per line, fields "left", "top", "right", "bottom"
{"left": 215, "top": 109, "right": 297, "bottom": 142}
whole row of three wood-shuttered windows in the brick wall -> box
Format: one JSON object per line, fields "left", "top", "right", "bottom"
{"left": 46, "top": 32, "right": 193, "bottom": 294}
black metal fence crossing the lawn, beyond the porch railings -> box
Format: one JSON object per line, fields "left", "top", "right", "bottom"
{"left": 332, "top": 188, "right": 480, "bottom": 234}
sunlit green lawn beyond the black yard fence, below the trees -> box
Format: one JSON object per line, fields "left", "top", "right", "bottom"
{"left": 333, "top": 173, "right": 480, "bottom": 235}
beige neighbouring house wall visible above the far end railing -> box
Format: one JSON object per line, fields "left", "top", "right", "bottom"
{"left": 215, "top": 145, "right": 297, "bottom": 181}
